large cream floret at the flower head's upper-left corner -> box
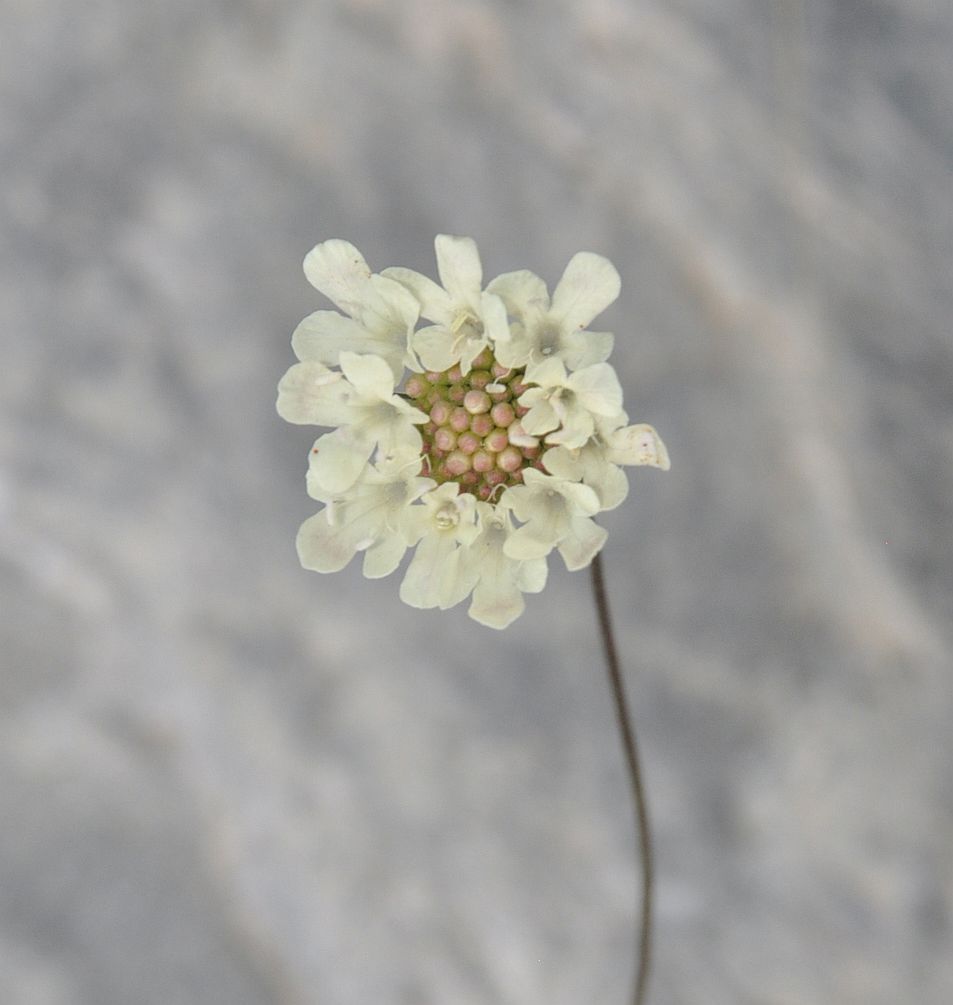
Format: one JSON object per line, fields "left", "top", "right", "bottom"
{"left": 292, "top": 240, "right": 420, "bottom": 380}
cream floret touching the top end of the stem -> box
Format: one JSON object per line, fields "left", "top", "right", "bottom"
{"left": 504, "top": 468, "right": 607, "bottom": 571}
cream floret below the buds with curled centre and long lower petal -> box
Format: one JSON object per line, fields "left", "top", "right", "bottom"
{"left": 400, "top": 481, "right": 480, "bottom": 610}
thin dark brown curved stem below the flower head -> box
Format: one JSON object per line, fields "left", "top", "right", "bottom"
{"left": 592, "top": 555, "right": 654, "bottom": 1005}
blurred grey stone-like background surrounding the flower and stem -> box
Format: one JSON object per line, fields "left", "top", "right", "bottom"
{"left": 0, "top": 0, "right": 953, "bottom": 1005}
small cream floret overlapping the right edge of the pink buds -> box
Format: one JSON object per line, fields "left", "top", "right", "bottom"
{"left": 520, "top": 358, "right": 622, "bottom": 447}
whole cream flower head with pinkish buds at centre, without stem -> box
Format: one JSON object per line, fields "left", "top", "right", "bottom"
{"left": 277, "top": 234, "right": 670, "bottom": 628}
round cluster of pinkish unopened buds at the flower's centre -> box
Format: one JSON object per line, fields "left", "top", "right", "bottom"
{"left": 404, "top": 349, "right": 545, "bottom": 500}
